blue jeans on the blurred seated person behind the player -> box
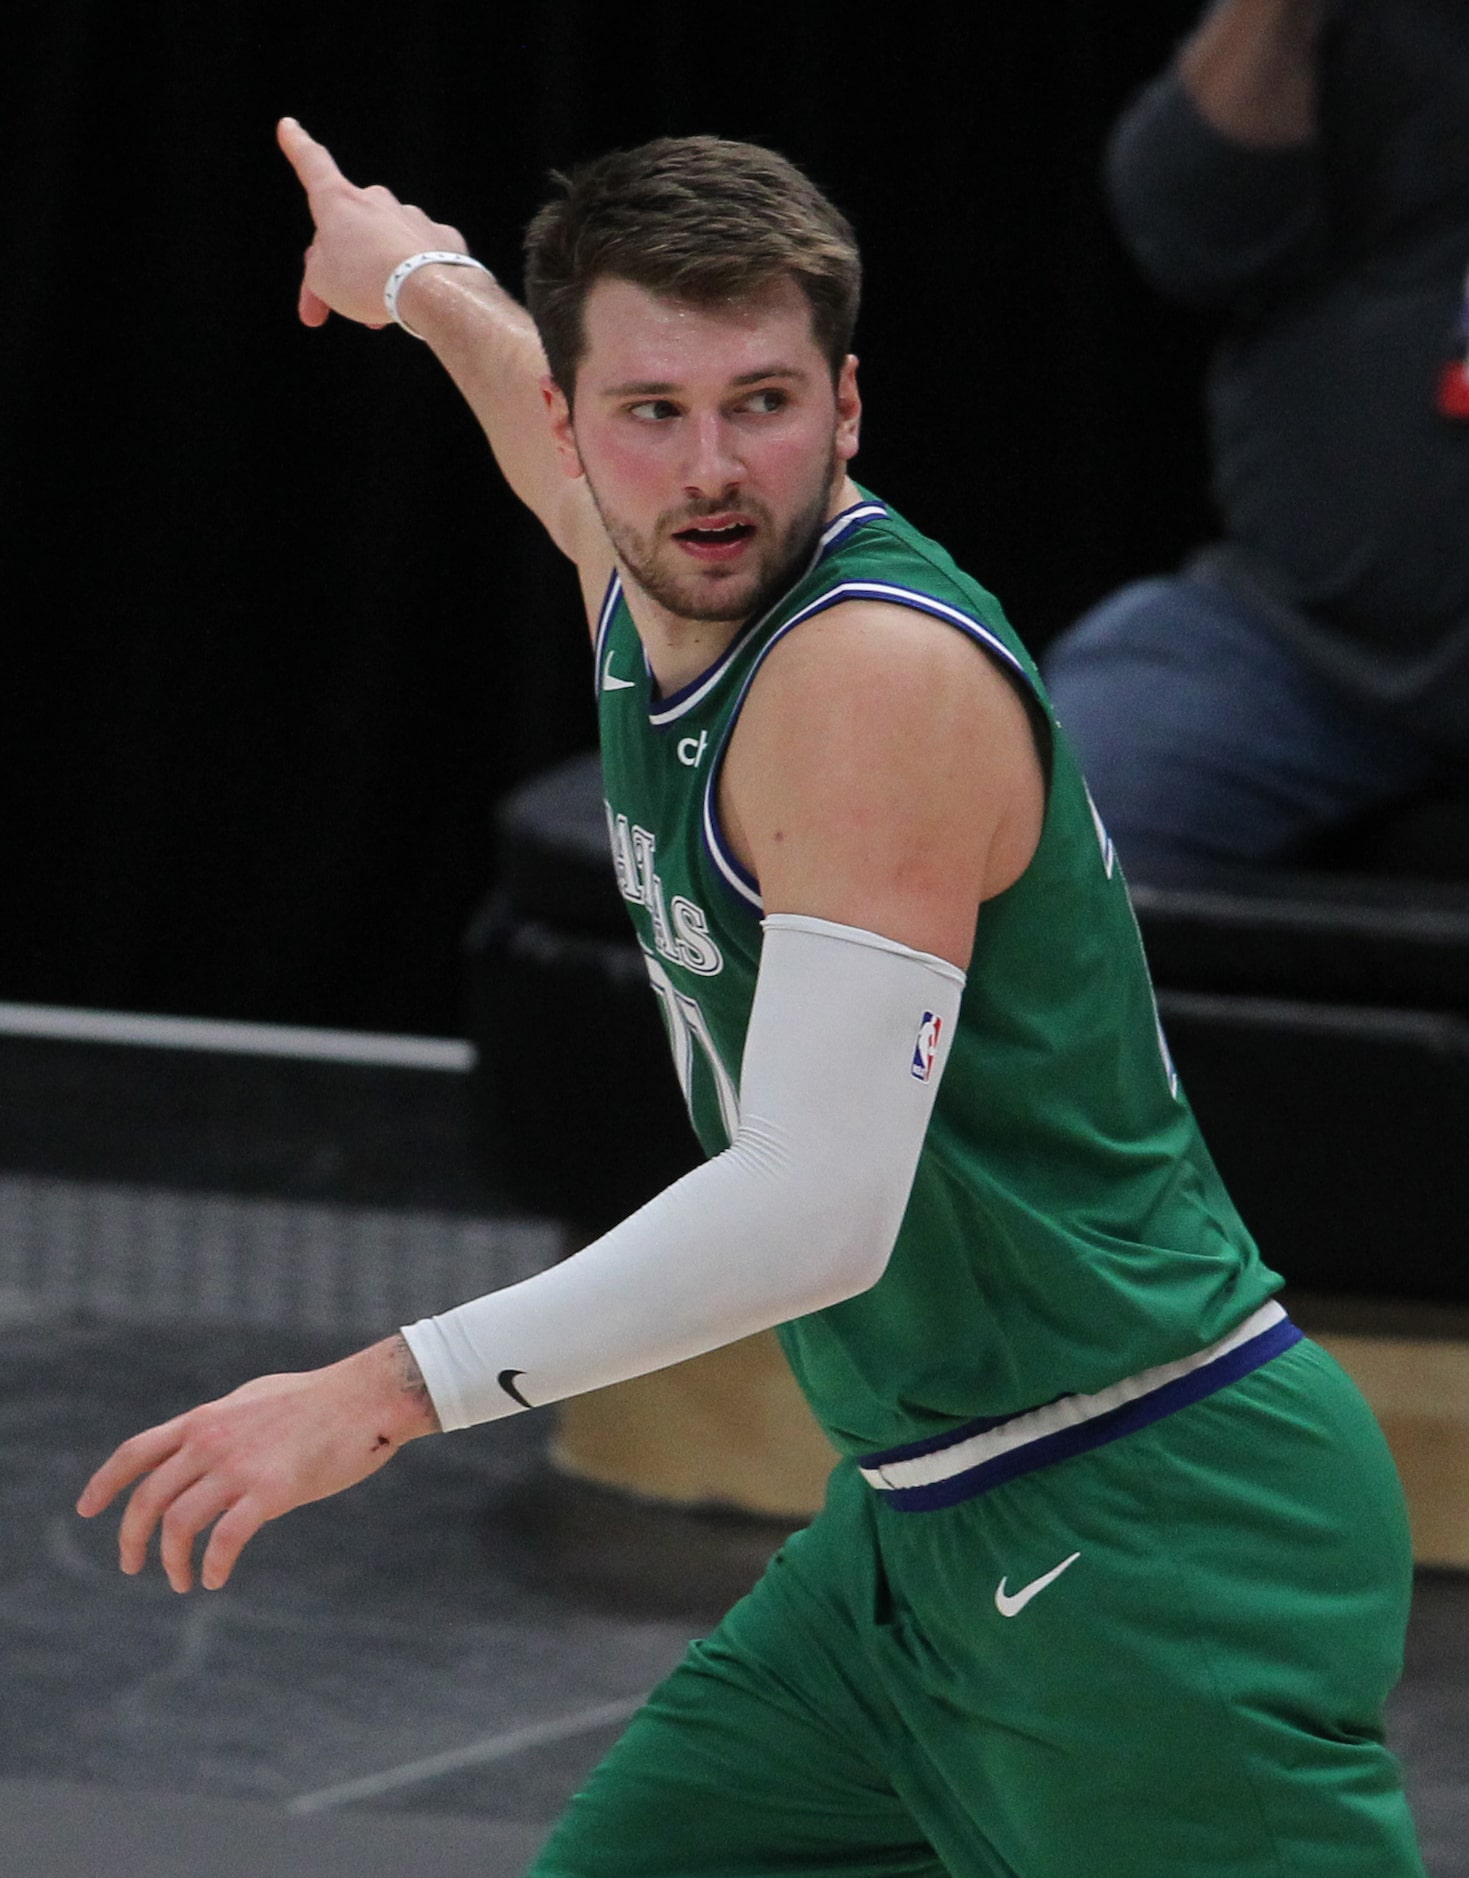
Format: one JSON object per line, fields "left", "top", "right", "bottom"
{"left": 1044, "top": 573, "right": 1437, "bottom": 879}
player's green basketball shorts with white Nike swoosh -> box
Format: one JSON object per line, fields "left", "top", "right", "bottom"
{"left": 535, "top": 1343, "right": 1422, "bottom": 1878}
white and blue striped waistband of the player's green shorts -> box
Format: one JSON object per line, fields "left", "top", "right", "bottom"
{"left": 858, "top": 1300, "right": 1302, "bottom": 1512}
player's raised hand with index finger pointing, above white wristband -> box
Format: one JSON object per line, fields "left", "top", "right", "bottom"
{"left": 276, "top": 118, "right": 464, "bottom": 327}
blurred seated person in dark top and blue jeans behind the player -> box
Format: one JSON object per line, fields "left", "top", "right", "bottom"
{"left": 1046, "top": 0, "right": 1469, "bottom": 879}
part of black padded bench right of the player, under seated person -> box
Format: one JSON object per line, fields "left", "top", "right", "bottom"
{"left": 1133, "top": 826, "right": 1469, "bottom": 1303}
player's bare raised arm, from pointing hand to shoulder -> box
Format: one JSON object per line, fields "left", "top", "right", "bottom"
{"left": 276, "top": 118, "right": 607, "bottom": 570}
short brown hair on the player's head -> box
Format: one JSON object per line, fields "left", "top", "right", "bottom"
{"left": 526, "top": 137, "right": 862, "bottom": 400}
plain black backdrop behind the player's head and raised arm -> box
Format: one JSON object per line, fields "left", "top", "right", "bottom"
{"left": 0, "top": 0, "right": 1210, "bottom": 1033}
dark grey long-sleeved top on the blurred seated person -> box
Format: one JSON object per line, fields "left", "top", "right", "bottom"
{"left": 1108, "top": 0, "right": 1469, "bottom": 755}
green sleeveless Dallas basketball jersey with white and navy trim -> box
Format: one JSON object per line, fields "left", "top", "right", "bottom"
{"left": 595, "top": 496, "right": 1279, "bottom": 1454}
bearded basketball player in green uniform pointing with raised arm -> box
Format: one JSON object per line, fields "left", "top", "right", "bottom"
{"left": 81, "top": 120, "right": 1422, "bottom": 1878}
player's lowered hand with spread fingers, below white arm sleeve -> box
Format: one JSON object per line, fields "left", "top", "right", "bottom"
{"left": 77, "top": 1337, "right": 438, "bottom": 1591}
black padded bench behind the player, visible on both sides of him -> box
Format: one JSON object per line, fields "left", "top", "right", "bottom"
{"left": 470, "top": 755, "right": 1469, "bottom": 1301}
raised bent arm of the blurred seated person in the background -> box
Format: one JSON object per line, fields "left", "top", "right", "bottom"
{"left": 1106, "top": 0, "right": 1328, "bottom": 304}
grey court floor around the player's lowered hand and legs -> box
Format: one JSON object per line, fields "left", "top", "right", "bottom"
{"left": 0, "top": 1039, "right": 1469, "bottom": 1878}
